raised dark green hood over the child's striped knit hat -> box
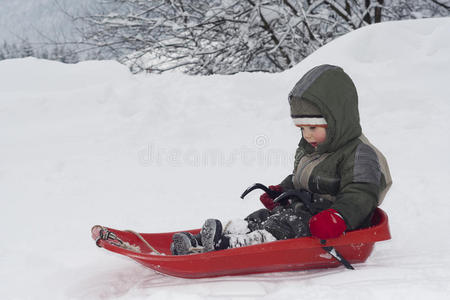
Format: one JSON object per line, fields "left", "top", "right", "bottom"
{"left": 289, "top": 65, "right": 361, "bottom": 153}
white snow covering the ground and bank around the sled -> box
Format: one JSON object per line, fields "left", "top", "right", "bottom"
{"left": 0, "top": 18, "right": 450, "bottom": 300}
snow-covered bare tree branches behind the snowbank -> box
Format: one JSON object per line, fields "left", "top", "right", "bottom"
{"left": 73, "top": 0, "right": 450, "bottom": 74}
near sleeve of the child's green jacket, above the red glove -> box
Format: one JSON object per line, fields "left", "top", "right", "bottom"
{"left": 331, "top": 144, "right": 381, "bottom": 230}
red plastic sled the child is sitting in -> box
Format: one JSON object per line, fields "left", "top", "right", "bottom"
{"left": 92, "top": 208, "right": 391, "bottom": 278}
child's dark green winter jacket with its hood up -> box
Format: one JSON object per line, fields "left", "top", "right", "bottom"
{"left": 281, "top": 65, "right": 392, "bottom": 230}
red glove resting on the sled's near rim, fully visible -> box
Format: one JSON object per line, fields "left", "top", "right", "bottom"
{"left": 309, "top": 208, "right": 347, "bottom": 240}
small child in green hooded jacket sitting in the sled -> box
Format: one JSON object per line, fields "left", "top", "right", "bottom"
{"left": 171, "top": 65, "right": 392, "bottom": 255}
